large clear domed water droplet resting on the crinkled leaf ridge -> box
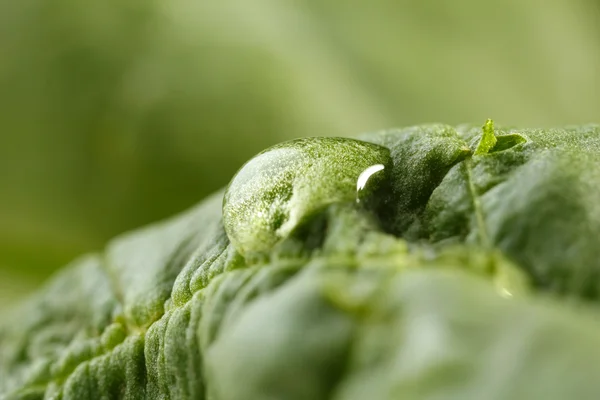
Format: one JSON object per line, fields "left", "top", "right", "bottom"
{"left": 223, "top": 138, "right": 391, "bottom": 258}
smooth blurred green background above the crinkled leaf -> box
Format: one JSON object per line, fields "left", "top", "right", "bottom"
{"left": 0, "top": 0, "right": 600, "bottom": 305}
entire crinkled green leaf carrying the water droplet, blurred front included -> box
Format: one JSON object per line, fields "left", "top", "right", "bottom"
{"left": 0, "top": 123, "right": 600, "bottom": 400}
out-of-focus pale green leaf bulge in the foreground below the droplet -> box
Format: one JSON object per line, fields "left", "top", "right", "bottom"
{"left": 206, "top": 265, "right": 600, "bottom": 400}
